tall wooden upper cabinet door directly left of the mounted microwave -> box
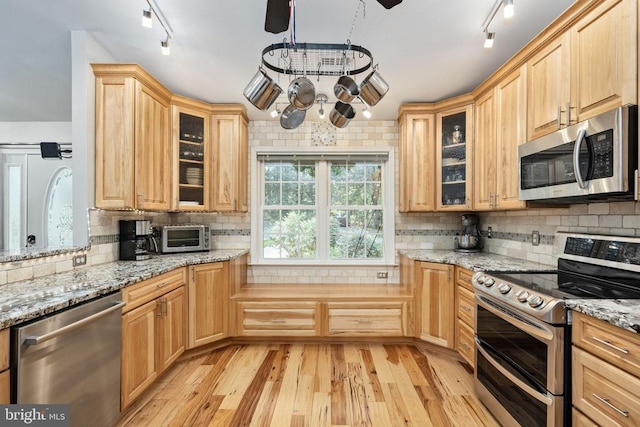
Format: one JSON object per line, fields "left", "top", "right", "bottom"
{"left": 494, "top": 65, "right": 527, "bottom": 209}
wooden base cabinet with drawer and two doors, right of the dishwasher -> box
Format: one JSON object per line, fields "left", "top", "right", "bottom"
{"left": 120, "top": 268, "right": 186, "bottom": 409}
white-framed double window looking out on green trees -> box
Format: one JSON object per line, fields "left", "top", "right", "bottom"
{"left": 252, "top": 151, "right": 395, "bottom": 264}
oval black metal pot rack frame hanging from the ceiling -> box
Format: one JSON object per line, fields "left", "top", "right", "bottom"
{"left": 262, "top": 39, "right": 373, "bottom": 76}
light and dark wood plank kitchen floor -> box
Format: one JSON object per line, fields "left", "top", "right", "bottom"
{"left": 118, "top": 343, "right": 499, "bottom": 427}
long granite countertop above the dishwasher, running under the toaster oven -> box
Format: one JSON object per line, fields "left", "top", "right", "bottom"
{"left": 0, "top": 249, "right": 248, "bottom": 329}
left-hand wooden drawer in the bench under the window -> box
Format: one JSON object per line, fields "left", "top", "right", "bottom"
{"left": 237, "top": 302, "right": 320, "bottom": 337}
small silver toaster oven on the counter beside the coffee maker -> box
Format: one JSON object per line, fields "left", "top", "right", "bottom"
{"left": 154, "top": 224, "right": 211, "bottom": 254}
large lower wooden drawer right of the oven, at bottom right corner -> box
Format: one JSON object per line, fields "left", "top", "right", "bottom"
{"left": 573, "top": 346, "right": 640, "bottom": 426}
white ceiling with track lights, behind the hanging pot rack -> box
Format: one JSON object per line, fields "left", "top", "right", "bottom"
{"left": 0, "top": 0, "right": 573, "bottom": 122}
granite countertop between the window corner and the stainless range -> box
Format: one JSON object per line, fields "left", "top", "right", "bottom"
{"left": 398, "top": 249, "right": 556, "bottom": 271}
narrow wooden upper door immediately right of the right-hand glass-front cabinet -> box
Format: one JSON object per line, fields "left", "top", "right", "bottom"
{"left": 473, "top": 90, "right": 497, "bottom": 210}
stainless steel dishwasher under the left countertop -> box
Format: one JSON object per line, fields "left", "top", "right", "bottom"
{"left": 11, "top": 292, "right": 124, "bottom": 427}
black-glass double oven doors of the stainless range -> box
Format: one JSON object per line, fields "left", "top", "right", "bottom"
{"left": 475, "top": 291, "right": 565, "bottom": 426}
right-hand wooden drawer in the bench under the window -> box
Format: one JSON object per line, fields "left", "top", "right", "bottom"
{"left": 327, "top": 302, "right": 404, "bottom": 336}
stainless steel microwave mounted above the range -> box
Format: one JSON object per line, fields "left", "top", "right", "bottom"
{"left": 518, "top": 105, "right": 638, "bottom": 203}
